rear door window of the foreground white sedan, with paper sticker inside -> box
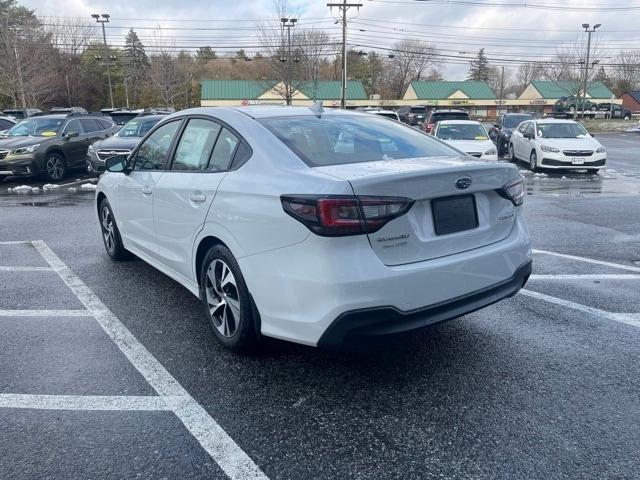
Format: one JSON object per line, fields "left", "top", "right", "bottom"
{"left": 171, "top": 118, "right": 222, "bottom": 171}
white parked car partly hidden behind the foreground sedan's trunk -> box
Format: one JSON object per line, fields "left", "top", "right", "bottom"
{"left": 431, "top": 120, "right": 498, "bottom": 161}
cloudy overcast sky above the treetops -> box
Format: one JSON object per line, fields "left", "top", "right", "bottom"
{"left": 18, "top": 0, "right": 640, "bottom": 80}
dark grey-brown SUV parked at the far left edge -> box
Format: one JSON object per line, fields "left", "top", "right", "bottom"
{"left": 0, "top": 114, "right": 117, "bottom": 181}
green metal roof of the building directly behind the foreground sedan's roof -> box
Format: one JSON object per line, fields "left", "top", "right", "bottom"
{"left": 200, "top": 80, "right": 367, "bottom": 100}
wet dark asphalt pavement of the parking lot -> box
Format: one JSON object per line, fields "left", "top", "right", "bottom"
{"left": 0, "top": 134, "right": 640, "bottom": 479}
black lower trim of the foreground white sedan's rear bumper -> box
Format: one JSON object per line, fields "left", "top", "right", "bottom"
{"left": 318, "top": 260, "right": 533, "bottom": 349}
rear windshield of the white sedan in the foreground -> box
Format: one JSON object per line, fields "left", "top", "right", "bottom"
{"left": 260, "top": 115, "right": 459, "bottom": 167}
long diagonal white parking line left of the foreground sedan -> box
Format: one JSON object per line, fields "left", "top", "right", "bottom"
{"left": 26, "top": 240, "right": 268, "bottom": 480}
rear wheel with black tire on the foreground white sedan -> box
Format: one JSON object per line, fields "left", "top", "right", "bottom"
{"left": 200, "top": 245, "right": 259, "bottom": 353}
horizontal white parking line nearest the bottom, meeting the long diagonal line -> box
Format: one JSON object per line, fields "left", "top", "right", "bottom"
{"left": 0, "top": 393, "right": 175, "bottom": 411}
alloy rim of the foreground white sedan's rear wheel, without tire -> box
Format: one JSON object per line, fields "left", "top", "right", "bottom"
{"left": 205, "top": 259, "right": 240, "bottom": 338}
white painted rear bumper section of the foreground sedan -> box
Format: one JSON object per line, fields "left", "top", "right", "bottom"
{"left": 238, "top": 212, "right": 531, "bottom": 346}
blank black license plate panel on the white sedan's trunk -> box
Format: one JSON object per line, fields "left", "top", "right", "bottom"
{"left": 431, "top": 195, "right": 479, "bottom": 235}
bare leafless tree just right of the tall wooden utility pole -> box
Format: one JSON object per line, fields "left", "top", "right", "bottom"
{"left": 387, "top": 37, "right": 440, "bottom": 98}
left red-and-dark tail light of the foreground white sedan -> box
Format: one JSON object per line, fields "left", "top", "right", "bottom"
{"left": 280, "top": 195, "right": 413, "bottom": 237}
